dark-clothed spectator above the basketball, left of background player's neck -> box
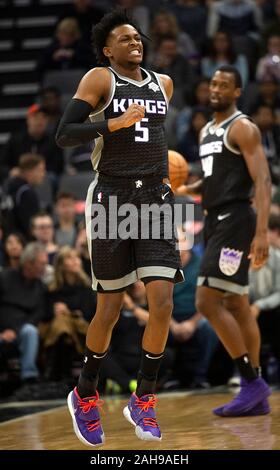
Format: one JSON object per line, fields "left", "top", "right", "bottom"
{"left": 177, "top": 106, "right": 210, "bottom": 163}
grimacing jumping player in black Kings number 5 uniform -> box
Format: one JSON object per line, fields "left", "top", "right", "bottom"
{"left": 57, "top": 11, "right": 183, "bottom": 446}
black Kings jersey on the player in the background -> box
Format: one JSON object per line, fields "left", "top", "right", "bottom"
{"left": 199, "top": 111, "right": 253, "bottom": 209}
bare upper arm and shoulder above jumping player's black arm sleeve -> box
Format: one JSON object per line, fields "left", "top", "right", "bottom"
{"left": 74, "top": 67, "right": 111, "bottom": 108}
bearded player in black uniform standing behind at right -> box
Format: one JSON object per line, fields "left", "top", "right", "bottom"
{"left": 178, "top": 66, "right": 271, "bottom": 416}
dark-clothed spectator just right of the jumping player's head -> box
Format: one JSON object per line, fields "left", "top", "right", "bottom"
{"left": 150, "top": 35, "right": 195, "bottom": 109}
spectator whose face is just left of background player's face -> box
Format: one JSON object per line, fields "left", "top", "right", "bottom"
{"left": 176, "top": 77, "right": 209, "bottom": 141}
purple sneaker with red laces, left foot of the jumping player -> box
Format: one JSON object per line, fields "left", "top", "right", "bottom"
{"left": 67, "top": 387, "right": 105, "bottom": 447}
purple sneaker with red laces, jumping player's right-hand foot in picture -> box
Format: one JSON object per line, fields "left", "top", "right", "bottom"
{"left": 123, "top": 393, "right": 161, "bottom": 441}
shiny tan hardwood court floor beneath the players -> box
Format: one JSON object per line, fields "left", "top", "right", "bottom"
{"left": 0, "top": 391, "right": 280, "bottom": 450}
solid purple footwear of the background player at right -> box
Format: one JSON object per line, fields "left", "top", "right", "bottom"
{"left": 213, "top": 377, "right": 271, "bottom": 417}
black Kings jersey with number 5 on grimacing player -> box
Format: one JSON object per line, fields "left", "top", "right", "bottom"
{"left": 90, "top": 67, "right": 168, "bottom": 178}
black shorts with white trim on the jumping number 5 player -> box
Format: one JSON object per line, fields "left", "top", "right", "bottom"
{"left": 83, "top": 174, "right": 184, "bottom": 292}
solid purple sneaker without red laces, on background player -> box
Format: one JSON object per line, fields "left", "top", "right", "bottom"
{"left": 217, "top": 377, "right": 271, "bottom": 416}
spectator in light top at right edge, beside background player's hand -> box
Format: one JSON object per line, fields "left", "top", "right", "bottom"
{"left": 249, "top": 216, "right": 280, "bottom": 381}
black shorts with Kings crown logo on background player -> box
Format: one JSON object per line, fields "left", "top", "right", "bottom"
{"left": 197, "top": 202, "right": 256, "bottom": 295}
